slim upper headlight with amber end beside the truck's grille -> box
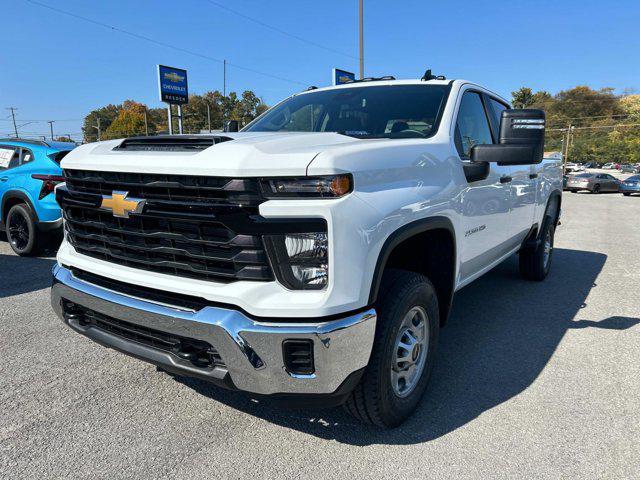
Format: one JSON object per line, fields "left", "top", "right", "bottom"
{"left": 262, "top": 174, "right": 353, "bottom": 198}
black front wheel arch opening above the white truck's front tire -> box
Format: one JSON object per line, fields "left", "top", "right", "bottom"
{"left": 369, "top": 216, "right": 457, "bottom": 325}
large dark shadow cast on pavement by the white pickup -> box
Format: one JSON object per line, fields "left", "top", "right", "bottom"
{"left": 172, "top": 248, "right": 612, "bottom": 445}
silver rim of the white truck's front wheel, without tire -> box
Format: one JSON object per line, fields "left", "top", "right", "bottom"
{"left": 391, "top": 307, "right": 429, "bottom": 398}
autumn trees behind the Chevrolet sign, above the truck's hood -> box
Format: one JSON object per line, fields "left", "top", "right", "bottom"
{"left": 82, "top": 90, "right": 268, "bottom": 142}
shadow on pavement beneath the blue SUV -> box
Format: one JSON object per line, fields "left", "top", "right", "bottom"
{"left": 0, "top": 253, "right": 55, "bottom": 298}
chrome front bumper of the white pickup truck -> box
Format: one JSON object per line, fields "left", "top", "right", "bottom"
{"left": 51, "top": 265, "right": 376, "bottom": 395}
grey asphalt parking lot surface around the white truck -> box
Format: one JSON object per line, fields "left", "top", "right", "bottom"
{"left": 0, "top": 193, "right": 640, "bottom": 479}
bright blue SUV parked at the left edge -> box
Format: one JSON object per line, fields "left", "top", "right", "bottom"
{"left": 0, "top": 138, "right": 75, "bottom": 255}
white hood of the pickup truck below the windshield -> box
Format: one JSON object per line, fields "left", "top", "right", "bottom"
{"left": 62, "top": 132, "right": 379, "bottom": 177}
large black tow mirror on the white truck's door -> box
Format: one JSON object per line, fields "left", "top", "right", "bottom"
{"left": 471, "top": 109, "right": 545, "bottom": 165}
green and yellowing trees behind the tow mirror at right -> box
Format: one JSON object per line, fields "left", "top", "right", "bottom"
{"left": 512, "top": 86, "right": 640, "bottom": 163}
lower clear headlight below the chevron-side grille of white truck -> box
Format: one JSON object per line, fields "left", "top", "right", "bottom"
{"left": 265, "top": 232, "right": 329, "bottom": 290}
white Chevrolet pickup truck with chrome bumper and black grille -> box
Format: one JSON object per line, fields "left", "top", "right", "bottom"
{"left": 52, "top": 78, "right": 562, "bottom": 427}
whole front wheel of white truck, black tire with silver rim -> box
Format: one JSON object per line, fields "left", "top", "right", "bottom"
{"left": 345, "top": 270, "right": 440, "bottom": 428}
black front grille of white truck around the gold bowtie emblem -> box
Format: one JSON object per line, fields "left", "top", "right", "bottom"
{"left": 62, "top": 170, "right": 273, "bottom": 282}
